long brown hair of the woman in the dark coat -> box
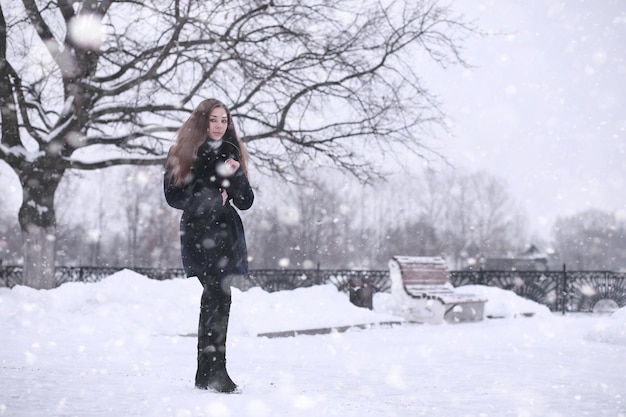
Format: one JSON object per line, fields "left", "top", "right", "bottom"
{"left": 167, "top": 98, "right": 248, "bottom": 185}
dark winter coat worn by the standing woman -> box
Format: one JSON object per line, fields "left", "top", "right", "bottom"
{"left": 163, "top": 139, "right": 254, "bottom": 282}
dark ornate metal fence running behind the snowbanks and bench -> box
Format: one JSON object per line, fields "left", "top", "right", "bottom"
{"left": 0, "top": 264, "right": 626, "bottom": 313}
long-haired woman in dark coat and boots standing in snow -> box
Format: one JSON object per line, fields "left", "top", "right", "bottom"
{"left": 163, "top": 99, "right": 254, "bottom": 392}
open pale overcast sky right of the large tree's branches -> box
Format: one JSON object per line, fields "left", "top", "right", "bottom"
{"left": 429, "top": 0, "right": 626, "bottom": 235}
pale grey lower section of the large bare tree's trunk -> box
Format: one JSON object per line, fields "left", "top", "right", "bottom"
{"left": 22, "top": 225, "right": 57, "bottom": 289}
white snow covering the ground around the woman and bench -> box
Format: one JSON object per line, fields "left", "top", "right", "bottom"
{"left": 0, "top": 271, "right": 626, "bottom": 417}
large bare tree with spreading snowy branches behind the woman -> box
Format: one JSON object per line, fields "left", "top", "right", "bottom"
{"left": 0, "top": 0, "right": 469, "bottom": 288}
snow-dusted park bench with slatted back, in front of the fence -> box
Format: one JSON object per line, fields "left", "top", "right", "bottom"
{"left": 389, "top": 256, "right": 487, "bottom": 324}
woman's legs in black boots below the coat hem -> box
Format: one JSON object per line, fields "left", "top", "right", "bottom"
{"left": 196, "top": 277, "right": 237, "bottom": 392}
